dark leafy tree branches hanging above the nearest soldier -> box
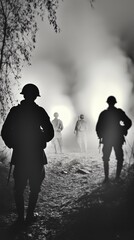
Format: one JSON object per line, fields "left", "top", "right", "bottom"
{"left": 0, "top": 0, "right": 59, "bottom": 118}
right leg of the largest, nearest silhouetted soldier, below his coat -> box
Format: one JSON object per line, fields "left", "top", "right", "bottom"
{"left": 26, "top": 166, "right": 45, "bottom": 223}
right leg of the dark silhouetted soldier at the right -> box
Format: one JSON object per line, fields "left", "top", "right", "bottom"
{"left": 114, "top": 144, "right": 124, "bottom": 179}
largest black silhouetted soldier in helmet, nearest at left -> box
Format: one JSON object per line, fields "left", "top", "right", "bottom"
{"left": 1, "top": 84, "right": 54, "bottom": 226}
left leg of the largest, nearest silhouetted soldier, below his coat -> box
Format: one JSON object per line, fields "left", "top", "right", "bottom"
{"left": 13, "top": 167, "right": 27, "bottom": 223}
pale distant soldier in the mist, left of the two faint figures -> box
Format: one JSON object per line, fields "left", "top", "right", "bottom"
{"left": 52, "top": 112, "right": 63, "bottom": 153}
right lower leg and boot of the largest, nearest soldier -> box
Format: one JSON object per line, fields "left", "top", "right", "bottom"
{"left": 26, "top": 192, "right": 38, "bottom": 224}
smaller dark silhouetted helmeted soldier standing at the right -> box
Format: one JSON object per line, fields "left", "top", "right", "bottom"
{"left": 96, "top": 96, "right": 132, "bottom": 182}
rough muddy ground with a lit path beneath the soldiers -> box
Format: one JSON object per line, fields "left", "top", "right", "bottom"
{"left": 0, "top": 152, "right": 134, "bottom": 240}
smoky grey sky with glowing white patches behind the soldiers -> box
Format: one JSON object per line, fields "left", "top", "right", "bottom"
{"left": 21, "top": 0, "right": 134, "bottom": 150}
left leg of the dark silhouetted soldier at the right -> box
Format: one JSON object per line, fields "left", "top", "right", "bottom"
{"left": 102, "top": 144, "right": 112, "bottom": 182}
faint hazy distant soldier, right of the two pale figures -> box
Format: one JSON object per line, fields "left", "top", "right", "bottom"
{"left": 74, "top": 114, "right": 88, "bottom": 152}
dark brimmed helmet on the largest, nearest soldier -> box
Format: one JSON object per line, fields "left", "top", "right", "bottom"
{"left": 20, "top": 83, "right": 40, "bottom": 97}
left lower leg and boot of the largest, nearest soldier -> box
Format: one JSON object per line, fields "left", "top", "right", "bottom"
{"left": 14, "top": 192, "right": 24, "bottom": 224}
